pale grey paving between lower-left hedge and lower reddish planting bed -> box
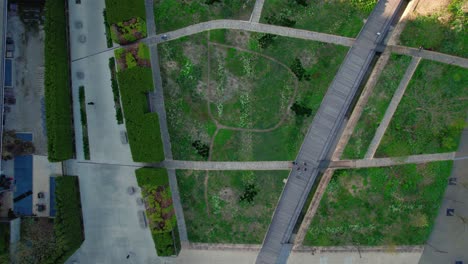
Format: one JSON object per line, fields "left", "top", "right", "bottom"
{"left": 65, "top": 161, "right": 160, "bottom": 264}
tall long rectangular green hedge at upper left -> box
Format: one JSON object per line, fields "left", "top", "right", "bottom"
{"left": 44, "top": 0, "right": 74, "bottom": 161}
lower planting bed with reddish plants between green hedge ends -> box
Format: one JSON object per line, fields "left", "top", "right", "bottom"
{"left": 135, "top": 168, "right": 180, "bottom": 256}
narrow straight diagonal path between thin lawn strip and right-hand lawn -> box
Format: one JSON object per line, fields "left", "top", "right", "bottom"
{"left": 364, "top": 57, "right": 421, "bottom": 159}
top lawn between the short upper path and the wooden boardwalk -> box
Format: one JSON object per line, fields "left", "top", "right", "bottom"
{"left": 260, "top": 0, "right": 377, "bottom": 37}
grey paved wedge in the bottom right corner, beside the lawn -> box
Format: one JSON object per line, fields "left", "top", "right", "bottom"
{"left": 419, "top": 119, "right": 468, "bottom": 264}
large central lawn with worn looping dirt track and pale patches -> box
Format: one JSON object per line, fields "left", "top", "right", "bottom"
{"left": 158, "top": 30, "right": 347, "bottom": 160}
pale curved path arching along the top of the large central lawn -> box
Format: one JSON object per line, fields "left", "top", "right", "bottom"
{"left": 145, "top": 19, "right": 354, "bottom": 47}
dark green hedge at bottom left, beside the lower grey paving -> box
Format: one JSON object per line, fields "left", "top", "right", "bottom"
{"left": 52, "top": 176, "right": 84, "bottom": 263}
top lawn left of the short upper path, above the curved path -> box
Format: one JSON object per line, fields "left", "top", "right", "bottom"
{"left": 154, "top": 0, "right": 255, "bottom": 32}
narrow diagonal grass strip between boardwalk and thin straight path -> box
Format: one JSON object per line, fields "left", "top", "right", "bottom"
{"left": 342, "top": 54, "right": 411, "bottom": 159}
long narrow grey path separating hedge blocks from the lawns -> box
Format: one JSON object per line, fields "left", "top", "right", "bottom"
{"left": 145, "top": 0, "right": 188, "bottom": 245}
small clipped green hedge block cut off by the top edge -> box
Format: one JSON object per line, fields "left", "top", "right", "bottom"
{"left": 106, "top": 0, "right": 146, "bottom": 25}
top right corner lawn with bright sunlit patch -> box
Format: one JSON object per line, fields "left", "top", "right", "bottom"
{"left": 400, "top": 0, "right": 468, "bottom": 58}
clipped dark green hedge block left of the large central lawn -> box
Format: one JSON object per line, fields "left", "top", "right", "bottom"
{"left": 117, "top": 67, "right": 164, "bottom": 162}
